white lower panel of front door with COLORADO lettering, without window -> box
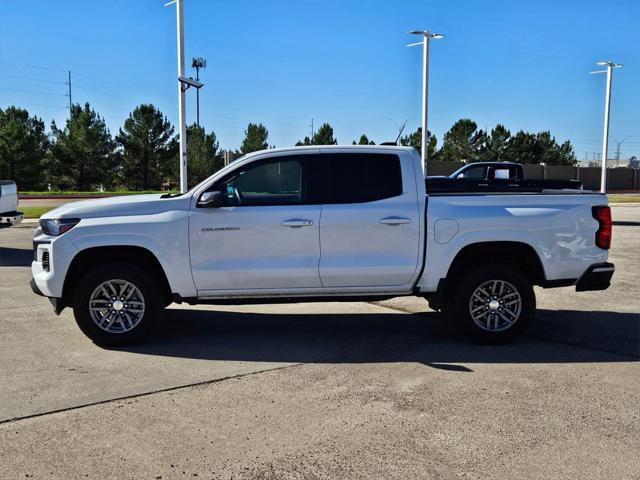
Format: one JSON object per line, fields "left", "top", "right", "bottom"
{"left": 189, "top": 205, "right": 322, "bottom": 290}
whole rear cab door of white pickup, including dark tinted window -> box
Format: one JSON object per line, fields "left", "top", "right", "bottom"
{"left": 320, "top": 151, "right": 422, "bottom": 290}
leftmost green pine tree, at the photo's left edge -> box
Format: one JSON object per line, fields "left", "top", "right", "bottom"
{"left": 0, "top": 106, "right": 49, "bottom": 190}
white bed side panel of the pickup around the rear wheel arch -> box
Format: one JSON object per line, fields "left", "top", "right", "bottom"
{"left": 418, "top": 194, "right": 608, "bottom": 292}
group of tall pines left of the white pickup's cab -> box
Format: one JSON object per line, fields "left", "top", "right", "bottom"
{"left": 0, "top": 103, "right": 224, "bottom": 191}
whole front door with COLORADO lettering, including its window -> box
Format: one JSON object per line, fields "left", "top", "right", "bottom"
{"left": 189, "top": 154, "right": 321, "bottom": 296}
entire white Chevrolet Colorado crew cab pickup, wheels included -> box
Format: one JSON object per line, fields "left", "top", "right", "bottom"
{"left": 31, "top": 146, "right": 614, "bottom": 345}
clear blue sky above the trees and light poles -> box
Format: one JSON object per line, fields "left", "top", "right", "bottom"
{"left": 0, "top": 0, "right": 640, "bottom": 159}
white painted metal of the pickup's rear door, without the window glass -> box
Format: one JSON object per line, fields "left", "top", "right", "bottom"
{"left": 320, "top": 149, "right": 424, "bottom": 291}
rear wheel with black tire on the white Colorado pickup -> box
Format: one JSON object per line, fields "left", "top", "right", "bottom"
{"left": 447, "top": 265, "right": 536, "bottom": 344}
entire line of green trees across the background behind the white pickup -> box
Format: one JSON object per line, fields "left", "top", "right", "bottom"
{"left": 0, "top": 103, "right": 576, "bottom": 191}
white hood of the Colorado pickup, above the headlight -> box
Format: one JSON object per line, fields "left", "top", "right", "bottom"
{"left": 40, "top": 194, "right": 191, "bottom": 219}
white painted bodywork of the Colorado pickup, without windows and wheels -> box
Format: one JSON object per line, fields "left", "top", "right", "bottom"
{"left": 32, "top": 146, "right": 607, "bottom": 304}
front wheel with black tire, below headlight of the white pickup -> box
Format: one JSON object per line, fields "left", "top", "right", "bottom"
{"left": 73, "top": 262, "right": 164, "bottom": 347}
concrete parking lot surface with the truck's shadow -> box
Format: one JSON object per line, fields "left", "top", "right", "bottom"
{"left": 0, "top": 205, "right": 640, "bottom": 479}
